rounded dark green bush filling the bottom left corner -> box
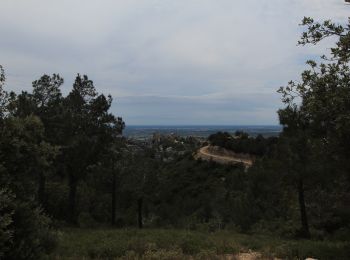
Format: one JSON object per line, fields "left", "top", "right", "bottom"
{"left": 0, "top": 190, "right": 57, "bottom": 259}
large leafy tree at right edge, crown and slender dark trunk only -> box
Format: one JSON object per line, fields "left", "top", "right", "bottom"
{"left": 279, "top": 18, "right": 350, "bottom": 237}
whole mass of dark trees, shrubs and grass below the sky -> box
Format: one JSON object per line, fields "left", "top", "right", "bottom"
{"left": 0, "top": 15, "right": 350, "bottom": 259}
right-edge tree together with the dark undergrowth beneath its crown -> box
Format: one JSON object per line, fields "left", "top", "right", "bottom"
{"left": 278, "top": 18, "right": 350, "bottom": 236}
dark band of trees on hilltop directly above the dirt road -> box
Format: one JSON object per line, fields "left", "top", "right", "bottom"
{"left": 208, "top": 131, "right": 277, "bottom": 156}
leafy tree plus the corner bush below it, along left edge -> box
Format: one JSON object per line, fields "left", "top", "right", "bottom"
{"left": 0, "top": 116, "right": 56, "bottom": 259}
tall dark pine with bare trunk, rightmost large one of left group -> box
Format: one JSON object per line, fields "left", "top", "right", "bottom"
{"left": 62, "top": 74, "right": 124, "bottom": 223}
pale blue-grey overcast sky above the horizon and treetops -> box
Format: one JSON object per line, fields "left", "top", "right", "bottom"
{"left": 0, "top": 0, "right": 350, "bottom": 125}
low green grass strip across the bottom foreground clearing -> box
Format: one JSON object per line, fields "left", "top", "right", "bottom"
{"left": 49, "top": 229, "right": 350, "bottom": 259}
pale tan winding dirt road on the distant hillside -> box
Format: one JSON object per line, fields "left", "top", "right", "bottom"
{"left": 196, "top": 146, "right": 253, "bottom": 167}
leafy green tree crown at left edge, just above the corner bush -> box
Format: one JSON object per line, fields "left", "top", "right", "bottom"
{"left": 0, "top": 116, "right": 58, "bottom": 203}
